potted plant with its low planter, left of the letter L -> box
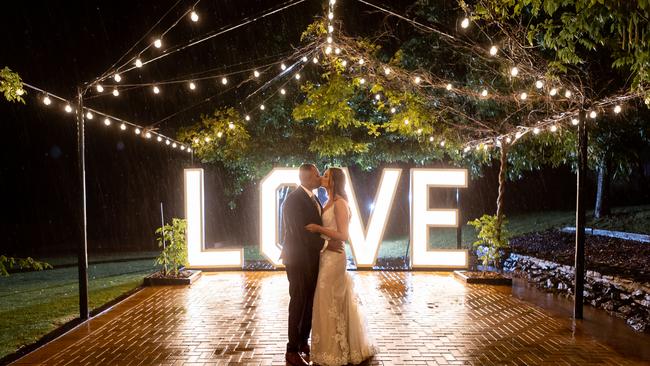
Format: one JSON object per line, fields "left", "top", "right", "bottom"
{"left": 144, "top": 218, "right": 201, "bottom": 286}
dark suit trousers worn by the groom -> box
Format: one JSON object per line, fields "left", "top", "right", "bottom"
{"left": 285, "top": 261, "right": 318, "bottom": 352}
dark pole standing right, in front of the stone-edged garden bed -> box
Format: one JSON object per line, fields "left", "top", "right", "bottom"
{"left": 573, "top": 116, "right": 587, "bottom": 319}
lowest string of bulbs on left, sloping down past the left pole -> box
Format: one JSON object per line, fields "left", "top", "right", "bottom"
{"left": 23, "top": 82, "right": 192, "bottom": 153}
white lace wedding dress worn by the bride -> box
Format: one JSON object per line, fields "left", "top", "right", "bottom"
{"left": 310, "top": 205, "right": 377, "bottom": 366}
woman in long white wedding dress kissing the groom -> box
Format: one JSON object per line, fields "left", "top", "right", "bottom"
{"left": 306, "top": 168, "right": 377, "bottom": 366}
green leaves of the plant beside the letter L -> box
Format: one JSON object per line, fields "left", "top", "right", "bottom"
{"left": 155, "top": 218, "right": 187, "bottom": 276}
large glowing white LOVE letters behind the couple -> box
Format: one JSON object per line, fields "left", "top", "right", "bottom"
{"left": 185, "top": 168, "right": 467, "bottom": 268}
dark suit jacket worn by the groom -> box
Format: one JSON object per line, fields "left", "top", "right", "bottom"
{"left": 280, "top": 187, "right": 325, "bottom": 266}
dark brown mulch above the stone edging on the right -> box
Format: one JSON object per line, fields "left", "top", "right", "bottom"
{"left": 510, "top": 230, "right": 650, "bottom": 282}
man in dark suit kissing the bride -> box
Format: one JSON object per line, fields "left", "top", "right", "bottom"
{"left": 280, "top": 164, "right": 343, "bottom": 365}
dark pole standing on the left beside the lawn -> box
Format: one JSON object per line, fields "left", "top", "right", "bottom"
{"left": 77, "top": 87, "right": 90, "bottom": 320}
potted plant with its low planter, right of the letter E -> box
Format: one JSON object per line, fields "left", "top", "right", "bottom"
{"left": 455, "top": 215, "right": 512, "bottom": 285}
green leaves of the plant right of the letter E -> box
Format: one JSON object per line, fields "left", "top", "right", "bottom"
{"left": 467, "top": 215, "right": 510, "bottom": 269}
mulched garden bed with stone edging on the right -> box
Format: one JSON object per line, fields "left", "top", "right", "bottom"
{"left": 504, "top": 231, "right": 650, "bottom": 332}
